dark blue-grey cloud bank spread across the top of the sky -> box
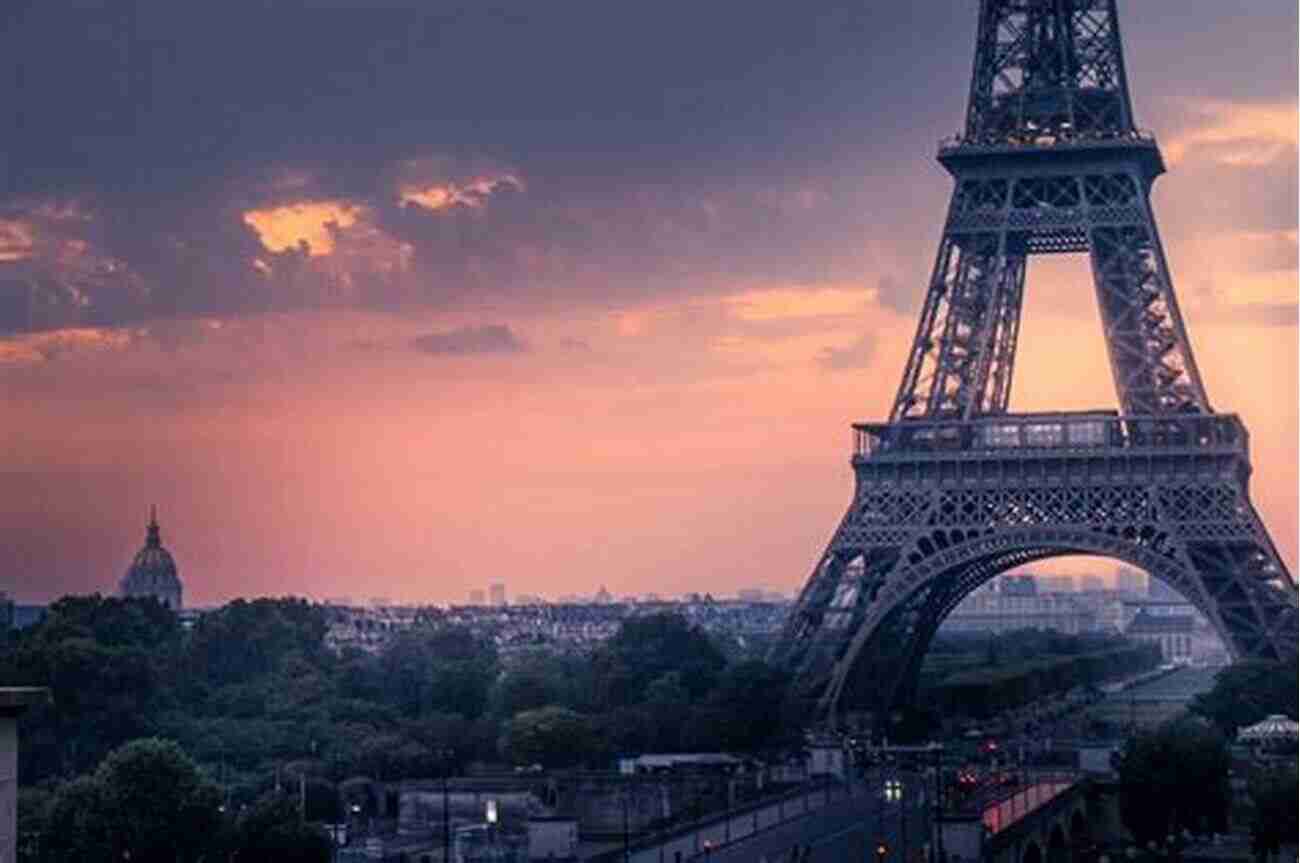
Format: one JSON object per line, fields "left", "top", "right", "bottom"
{"left": 0, "top": 0, "right": 1295, "bottom": 330}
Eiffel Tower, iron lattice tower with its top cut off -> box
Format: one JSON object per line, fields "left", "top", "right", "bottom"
{"left": 772, "top": 0, "right": 1297, "bottom": 725}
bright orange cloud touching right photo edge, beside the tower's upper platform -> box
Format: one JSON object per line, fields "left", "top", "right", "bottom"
{"left": 1164, "top": 101, "right": 1300, "bottom": 168}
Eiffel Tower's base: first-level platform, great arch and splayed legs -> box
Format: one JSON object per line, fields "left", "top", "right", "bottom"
{"left": 776, "top": 413, "right": 1300, "bottom": 714}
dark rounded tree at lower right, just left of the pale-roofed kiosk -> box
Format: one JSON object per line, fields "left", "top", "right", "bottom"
{"left": 1118, "top": 720, "right": 1232, "bottom": 844}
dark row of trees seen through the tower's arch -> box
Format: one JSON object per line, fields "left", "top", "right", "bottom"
{"left": 923, "top": 642, "right": 1161, "bottom": 719}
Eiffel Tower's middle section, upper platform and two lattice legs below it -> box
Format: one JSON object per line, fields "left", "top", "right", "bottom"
{"left": 892, "top": 161, "right": 1210, "bottom": 421}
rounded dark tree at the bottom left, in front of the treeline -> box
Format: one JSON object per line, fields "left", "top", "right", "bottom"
{"left": 43, "top": 738, "right": 221, "bottom": 863}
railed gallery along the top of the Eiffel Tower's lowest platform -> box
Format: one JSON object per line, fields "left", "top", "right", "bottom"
{"left": 853, "top": 412, "right": 1249, "bottom": 459}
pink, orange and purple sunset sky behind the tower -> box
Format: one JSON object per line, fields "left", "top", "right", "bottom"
{"left": 0, "top": 0, "right": 1300, "bottom": 604}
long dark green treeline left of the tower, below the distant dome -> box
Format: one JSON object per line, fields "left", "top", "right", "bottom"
{"left": 0, "top": 595, "right": 798, "bottom": 802}
